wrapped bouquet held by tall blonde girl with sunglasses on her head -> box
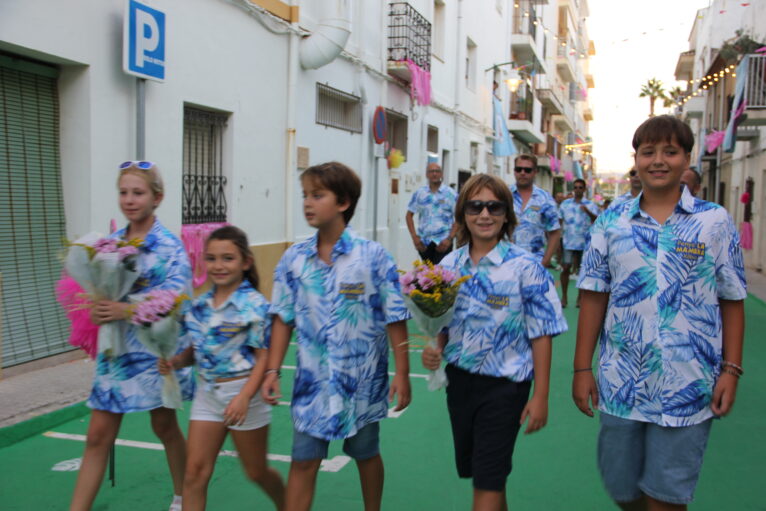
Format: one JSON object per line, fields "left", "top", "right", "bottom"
{"left": 64, "top": 233, "right": 142, "bottom": 357}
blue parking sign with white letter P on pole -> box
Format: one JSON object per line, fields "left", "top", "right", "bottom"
{"left": 122, "top": 0, "right": 166, "bottom": 82}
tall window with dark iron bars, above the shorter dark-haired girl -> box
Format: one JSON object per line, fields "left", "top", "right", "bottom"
{"left": 182, "top": 107, "right": 228, "bottom": 224}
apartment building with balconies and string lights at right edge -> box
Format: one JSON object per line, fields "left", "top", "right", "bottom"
{"left": 675, "top": 0, "right": 766, "bottom": 270}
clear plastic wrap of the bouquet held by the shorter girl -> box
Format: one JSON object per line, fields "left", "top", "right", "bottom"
{"left": 136, "top": 315, "right": 183, "bottom": 408}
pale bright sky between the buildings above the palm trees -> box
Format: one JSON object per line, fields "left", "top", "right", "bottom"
{"left": 586, "top": 0, "right": 710, "bottom": 174}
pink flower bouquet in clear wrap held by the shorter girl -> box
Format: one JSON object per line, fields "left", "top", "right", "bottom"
{"left": 130, "top": 289, "right": 189, "bottom": 408}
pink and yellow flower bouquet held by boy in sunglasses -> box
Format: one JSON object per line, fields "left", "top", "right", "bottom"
{"left": 399, "top": 261, "right": 470, "bottom": 390}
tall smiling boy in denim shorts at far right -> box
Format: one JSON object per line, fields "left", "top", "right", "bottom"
{"left": 572, "top": 115, "right": 747, "bottom": 510}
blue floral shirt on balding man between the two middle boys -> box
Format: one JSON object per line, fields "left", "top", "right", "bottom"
{"left": 407, "top": 185, "right": 457, "bottom": 245}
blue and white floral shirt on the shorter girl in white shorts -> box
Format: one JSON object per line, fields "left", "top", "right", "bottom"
{"left": 184, "top": 280, "right": 271, "bottom": 382}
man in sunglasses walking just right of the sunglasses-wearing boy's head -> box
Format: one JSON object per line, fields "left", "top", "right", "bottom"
{"left": 511, "top": 154, "right": 561, "bottom": 267}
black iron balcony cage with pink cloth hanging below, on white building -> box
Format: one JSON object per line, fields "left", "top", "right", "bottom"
{"left": 388, "top": 2, "right": 431, "bottom": 71}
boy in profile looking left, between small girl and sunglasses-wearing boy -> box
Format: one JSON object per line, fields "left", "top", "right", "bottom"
{"left": 262, "top": 162, "right": 410, "bottom": 510}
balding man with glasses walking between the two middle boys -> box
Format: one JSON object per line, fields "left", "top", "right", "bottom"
{"left": 406, "top": 163, "right": 457, "bottom": 264}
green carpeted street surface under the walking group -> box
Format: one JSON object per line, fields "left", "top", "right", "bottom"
{"left": 0, "top": 290, "right": 766, "bottom": 511}
